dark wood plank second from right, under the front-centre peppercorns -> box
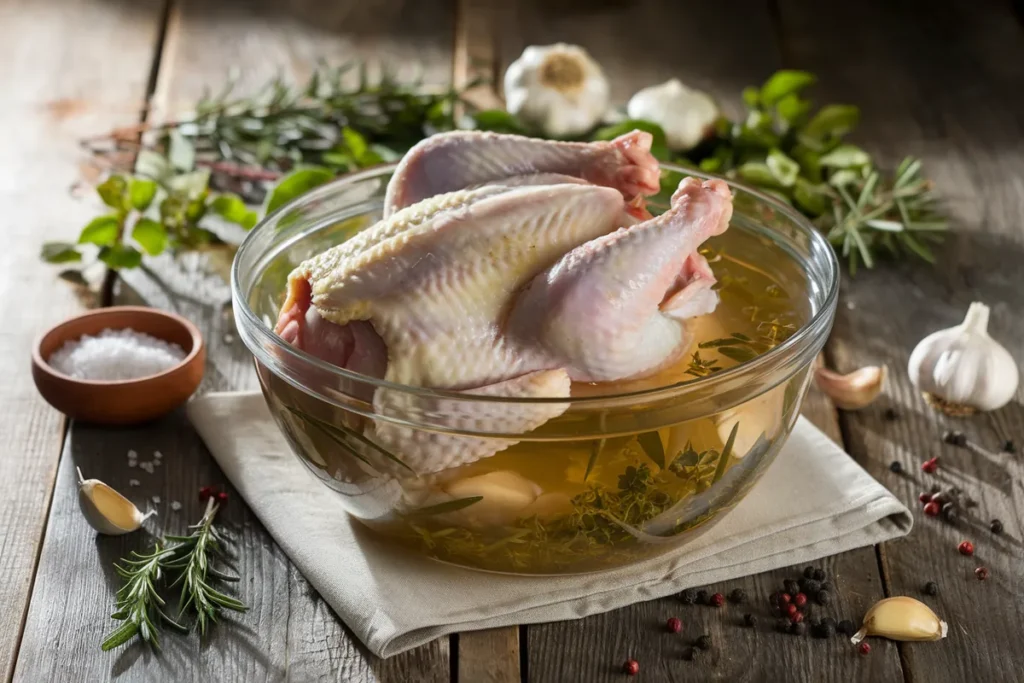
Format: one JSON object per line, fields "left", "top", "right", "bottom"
{"left": 501, "top": 1, "right": 903, "bottom": 682}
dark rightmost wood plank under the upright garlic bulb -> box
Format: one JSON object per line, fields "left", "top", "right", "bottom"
{"left": 779, "top": 0, "right": 1024, "bottom": 681}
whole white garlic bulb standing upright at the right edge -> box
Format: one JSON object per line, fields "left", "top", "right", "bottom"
{"left": 907, "top": 302, "right": 1020, "bottom": 414}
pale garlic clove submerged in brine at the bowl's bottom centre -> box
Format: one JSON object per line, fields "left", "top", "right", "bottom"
{"left": 444, "top": 470, "right": 541, "bottom": 525}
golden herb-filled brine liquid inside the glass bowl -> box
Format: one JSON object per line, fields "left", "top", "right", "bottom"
{"left": 268, "top": 229, "right": 810, "bottom": 573}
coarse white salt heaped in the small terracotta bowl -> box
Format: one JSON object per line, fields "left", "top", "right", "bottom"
{"left": 47, "top": 328, "right": 185, "bottom": 382}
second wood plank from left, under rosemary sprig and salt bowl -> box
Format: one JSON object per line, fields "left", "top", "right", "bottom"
{"left": 18, "top": 0, "right": 454, "bottom": 683}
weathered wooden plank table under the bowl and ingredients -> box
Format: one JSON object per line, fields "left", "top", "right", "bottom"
{"left": 0, "top": 0, "right": 1024, "bottom": 683}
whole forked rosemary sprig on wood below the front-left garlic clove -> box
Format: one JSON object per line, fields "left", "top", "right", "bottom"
{"left": 101, "top": 498, "right": 247, "bottom": 651}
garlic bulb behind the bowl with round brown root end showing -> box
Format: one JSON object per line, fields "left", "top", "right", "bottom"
{"left": 505, "top": 43, "right": 611, "bottom": 137}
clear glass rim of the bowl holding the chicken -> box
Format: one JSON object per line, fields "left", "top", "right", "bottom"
{"left": 231, "top": 162, "right": 841, "bottom": 407}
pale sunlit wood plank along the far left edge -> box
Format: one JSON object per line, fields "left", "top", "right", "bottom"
{"left": 0, "top": 0, "right": 161, "bottom": 681}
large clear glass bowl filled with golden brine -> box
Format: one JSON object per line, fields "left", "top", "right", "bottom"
{"left": 231, "top": 166, "right": 839, "bottom": 573}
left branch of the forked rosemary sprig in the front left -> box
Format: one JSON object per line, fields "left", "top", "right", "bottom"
{"left": 100, "top": 543, "right": 188, "bottom": 651}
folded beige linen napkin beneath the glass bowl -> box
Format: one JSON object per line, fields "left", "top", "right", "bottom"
{"left": 188, "top": 393, "right": 912, "bottom": 657}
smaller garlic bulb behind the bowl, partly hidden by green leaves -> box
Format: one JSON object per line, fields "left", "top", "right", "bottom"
{"left": 626, "top": 78, "right": 719, "bottom": 152}
